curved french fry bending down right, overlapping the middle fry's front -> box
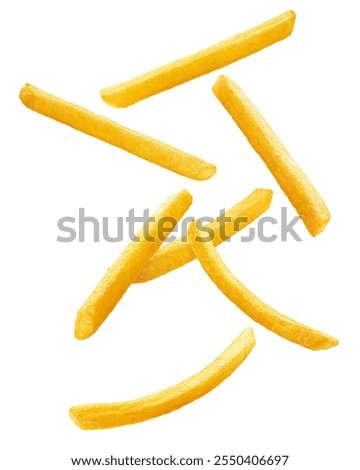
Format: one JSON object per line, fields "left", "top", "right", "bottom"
{"left": 188, "top": 222, "right": 338, "bottom": 351}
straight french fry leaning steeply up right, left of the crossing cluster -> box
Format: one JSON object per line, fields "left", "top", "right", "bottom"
{"left": 75, "top": 190, "right": 192, "bottom": 339}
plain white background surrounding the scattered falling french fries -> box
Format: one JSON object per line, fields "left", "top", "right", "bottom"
{"left": 0, "top": 0, "right": 360, "bottom": 470}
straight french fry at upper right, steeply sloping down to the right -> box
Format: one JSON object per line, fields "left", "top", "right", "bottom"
{"left": 213, "top": 76, "right": 330, "bottom": 237}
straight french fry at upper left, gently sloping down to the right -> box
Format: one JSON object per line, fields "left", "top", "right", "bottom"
{"left": 20, "top": 84, "right": 216, "bottom": 180}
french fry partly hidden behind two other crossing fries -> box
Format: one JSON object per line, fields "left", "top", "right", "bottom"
{"left": 135, "top": 189, "right": 272, "bottom": 282}
